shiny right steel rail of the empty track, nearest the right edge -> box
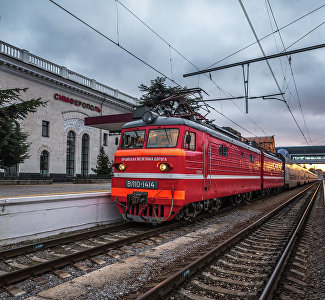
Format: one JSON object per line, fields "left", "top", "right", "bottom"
{"left": 259, "top": 184, "right": 321, "bottom": 300}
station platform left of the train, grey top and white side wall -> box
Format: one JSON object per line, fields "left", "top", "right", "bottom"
{"left": 0, "top": 183, "right": 122, "bottom": 246}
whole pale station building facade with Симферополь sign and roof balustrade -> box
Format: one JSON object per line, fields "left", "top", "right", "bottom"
{"left": 0, "top": 41, "right": 137, "bottom": 181}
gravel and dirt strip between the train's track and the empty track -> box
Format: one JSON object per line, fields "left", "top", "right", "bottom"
{"left": 0, "top": 186, "right": 316, "bottom": 300}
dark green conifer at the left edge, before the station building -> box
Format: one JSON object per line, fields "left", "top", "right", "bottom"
{"left": 0, "top": 88, "right": 46, "bottom": 169}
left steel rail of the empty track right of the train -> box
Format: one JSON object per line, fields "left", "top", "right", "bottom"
{"left": 136, "top": 184, "right": 315, "bottom": 300}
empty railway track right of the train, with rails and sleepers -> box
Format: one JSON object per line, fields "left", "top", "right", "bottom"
{"left": 135, "top": 185, "right": 319, "bottom": 300}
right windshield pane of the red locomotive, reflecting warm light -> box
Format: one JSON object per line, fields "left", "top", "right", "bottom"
{"left": 147, "top": 128, "right": 179, "bottom": 148}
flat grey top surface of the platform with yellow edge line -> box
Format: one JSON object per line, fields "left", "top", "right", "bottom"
{"left": 0, "top": 183, "right": 111, "bottom": 198}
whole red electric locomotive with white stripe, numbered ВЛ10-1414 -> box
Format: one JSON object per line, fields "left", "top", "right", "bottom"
{"left": 111, "top": 111, "right": 314, "bottom": 223}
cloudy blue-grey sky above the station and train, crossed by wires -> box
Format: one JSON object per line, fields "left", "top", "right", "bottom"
{"left": 0, "top": 0, "right": 325, "bottom": 146}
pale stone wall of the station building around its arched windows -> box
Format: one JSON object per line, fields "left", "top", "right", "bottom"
{"left": 0, "top": 70, "right": 123, "bottom": 175}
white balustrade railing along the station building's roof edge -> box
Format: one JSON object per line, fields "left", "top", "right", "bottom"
{"left": 0, "top": 41, "right": 137, "bottom": 105}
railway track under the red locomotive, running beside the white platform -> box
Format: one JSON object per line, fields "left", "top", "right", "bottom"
{"left": 0, "top": 200, "right": 237, "bottom": 296}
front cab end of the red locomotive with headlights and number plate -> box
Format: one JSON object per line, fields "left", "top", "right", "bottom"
{"left": 111, "top": 117, "right": 189, "bottom": 223}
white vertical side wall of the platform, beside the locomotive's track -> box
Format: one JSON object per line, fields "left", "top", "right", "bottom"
{"left": 0, "top": 192, "right": 122, "bottom": 245}
